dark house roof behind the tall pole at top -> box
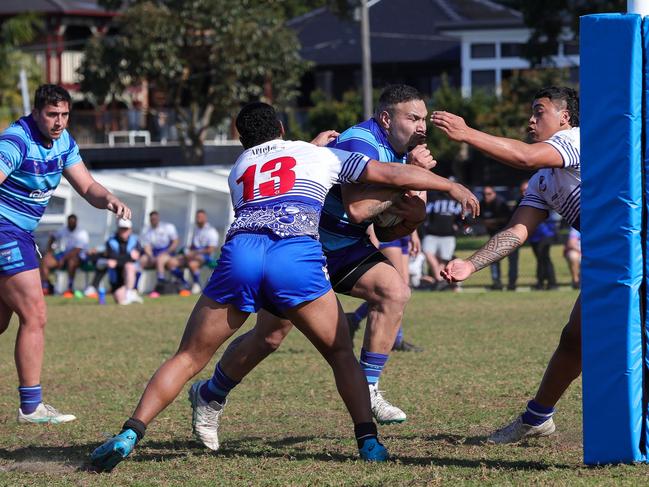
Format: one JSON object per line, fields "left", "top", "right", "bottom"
{"left": 288, "top": 0, "right": 524, "bottom": 65}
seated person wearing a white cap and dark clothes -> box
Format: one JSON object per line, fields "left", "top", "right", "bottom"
{"left": 84, "top": 219, "right": 142, "bottom": 304}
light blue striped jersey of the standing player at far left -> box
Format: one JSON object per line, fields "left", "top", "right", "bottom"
{"left": 0, "top": 115, "right": 81, "bottom": 232}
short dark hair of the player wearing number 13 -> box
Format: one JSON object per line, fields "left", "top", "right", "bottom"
{"left": 235, "top": 101, "right": 282, "bottom": 149}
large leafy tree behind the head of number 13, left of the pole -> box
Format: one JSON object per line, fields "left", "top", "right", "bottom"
{"left": 80, "top": 0, "right": 307, "bottom": 162}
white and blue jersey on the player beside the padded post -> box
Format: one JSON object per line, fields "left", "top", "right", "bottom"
{"left": 520, "top": 127, "right": 581, "bottom": 229}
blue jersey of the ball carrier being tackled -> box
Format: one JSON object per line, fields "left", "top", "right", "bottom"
{"left": 319, "top": 118, "right": 406, "bottom": 251}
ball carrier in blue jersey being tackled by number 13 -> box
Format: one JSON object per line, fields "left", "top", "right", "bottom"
{"left": 215, "top": 85, "right": 436, "bottom": 434}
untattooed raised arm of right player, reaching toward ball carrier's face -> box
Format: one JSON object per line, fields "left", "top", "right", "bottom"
{"left": 430, "top": 111, "right": 563, "bottom": 170}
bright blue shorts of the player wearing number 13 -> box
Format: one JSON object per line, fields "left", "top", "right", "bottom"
{"left": 203, "top": 233, "right": 331, "bottom": 313}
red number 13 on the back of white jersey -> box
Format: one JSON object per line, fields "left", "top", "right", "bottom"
{"left": 237, "top": 157, "right": 296, "bottom": 202}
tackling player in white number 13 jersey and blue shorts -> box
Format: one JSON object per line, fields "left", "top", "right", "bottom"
{"left": 91, "top": 102, "right": 479, "bottom": 471}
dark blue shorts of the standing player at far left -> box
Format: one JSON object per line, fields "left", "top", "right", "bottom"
{"left": 0, "top": 220, "right": 39, "bottom": 276}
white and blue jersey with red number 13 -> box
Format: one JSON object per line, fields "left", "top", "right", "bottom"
{"left": 227, "top": 139, "right": 369, "bottom": 239}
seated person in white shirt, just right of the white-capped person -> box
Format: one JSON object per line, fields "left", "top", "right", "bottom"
{"left": 140, "top": 210, "right": 187, "bottom": 297}
